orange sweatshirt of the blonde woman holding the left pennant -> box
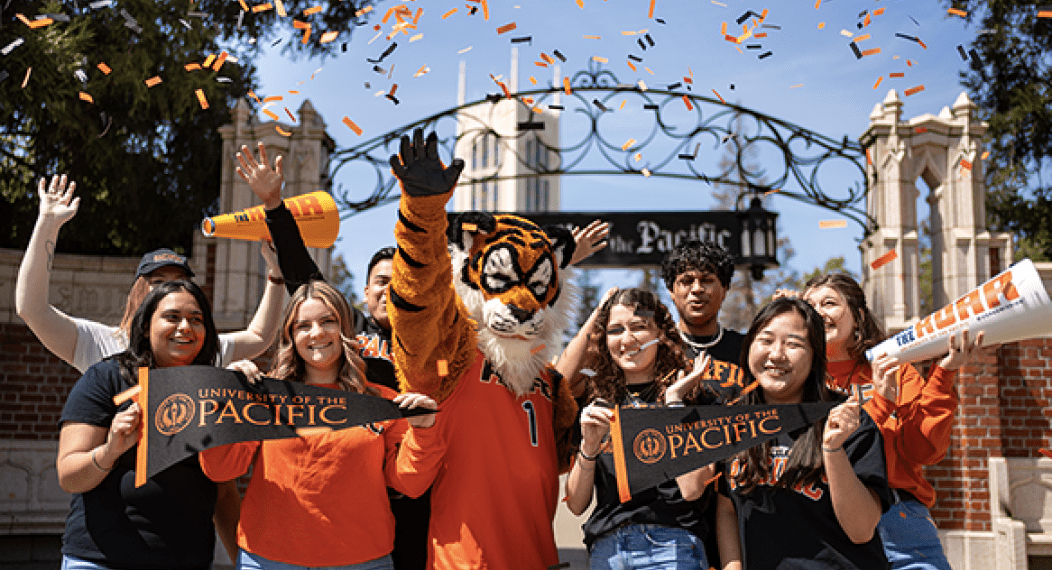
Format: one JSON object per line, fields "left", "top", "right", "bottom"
{"left": 199, "top": 385, "right": 442, "bottom": 566}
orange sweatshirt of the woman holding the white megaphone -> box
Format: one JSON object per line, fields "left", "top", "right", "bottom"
{"left": 826, "top": 361, "right": 957, "bottom": 507}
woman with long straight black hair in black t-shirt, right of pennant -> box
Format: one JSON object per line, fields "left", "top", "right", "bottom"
{"left": 716, "top": 299, "right": 889, "bottom": 570}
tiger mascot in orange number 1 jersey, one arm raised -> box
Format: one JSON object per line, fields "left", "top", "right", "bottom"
{"left": 387, "top": 128, "right": 576, "bottom": 570}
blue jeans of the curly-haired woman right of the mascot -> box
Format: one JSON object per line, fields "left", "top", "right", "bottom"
{"left": 589, "top": 525, "right": 709, "bottom": 570}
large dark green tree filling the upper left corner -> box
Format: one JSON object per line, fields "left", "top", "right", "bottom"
{"left": 0, "top": 0, "right": 378, "bottom": 255}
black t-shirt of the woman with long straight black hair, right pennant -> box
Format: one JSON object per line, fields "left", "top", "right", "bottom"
{"left": 720, "top": 411, "right": 890, "bottom": 570}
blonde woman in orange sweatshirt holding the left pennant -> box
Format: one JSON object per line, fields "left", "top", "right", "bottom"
{"left": 201, "top": 281, "right": 441, "bottom": 570}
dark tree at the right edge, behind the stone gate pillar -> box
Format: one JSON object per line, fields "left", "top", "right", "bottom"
{"left": 944, "top": 0, "right": 1052, "bottom": 261}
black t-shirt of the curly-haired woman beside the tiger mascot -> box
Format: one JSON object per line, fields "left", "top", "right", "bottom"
{"left": 579, "top": 390, "right": 712, "bottom": 550}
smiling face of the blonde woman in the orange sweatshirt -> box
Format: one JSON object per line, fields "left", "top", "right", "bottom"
{"left": 289, "top": 298, "right": 343, "bottom": 384}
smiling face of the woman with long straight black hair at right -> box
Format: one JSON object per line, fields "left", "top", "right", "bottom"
{"left": 748, "top": 311, "right": 813, "bottom": 404}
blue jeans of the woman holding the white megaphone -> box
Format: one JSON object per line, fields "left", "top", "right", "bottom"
{"left": 876, "top": 498, "right": 951, "bottom": 570}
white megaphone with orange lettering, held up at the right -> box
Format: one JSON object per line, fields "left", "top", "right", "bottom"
{"left": 866, "top": 260, "right": 1052, "bottom": 363}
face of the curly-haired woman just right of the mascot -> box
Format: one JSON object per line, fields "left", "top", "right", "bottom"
{"left": 606, "top": 305, "right": 661, "bottom": 384}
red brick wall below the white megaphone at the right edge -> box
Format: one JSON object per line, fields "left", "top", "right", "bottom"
{"left": 925, "top": 339, "right": 1052, "bottom": 531}
